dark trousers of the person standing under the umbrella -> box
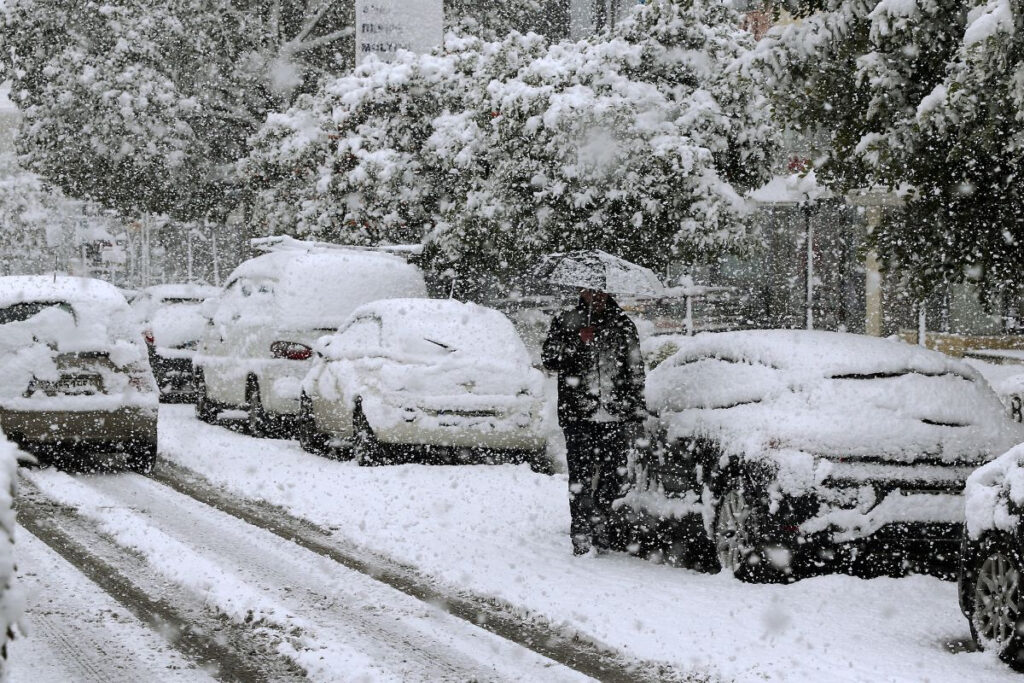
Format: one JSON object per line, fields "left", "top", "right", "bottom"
{"left": 562, "top": 422, "right": 636, "bottom": 551}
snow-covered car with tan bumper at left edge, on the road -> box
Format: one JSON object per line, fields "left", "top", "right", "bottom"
{"left": 0, "top": 275, "right": 158, "bottom": 472}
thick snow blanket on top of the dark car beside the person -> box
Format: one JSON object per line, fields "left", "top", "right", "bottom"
{"left": 646, "top": 330, "right": 1024, "bottom": 464}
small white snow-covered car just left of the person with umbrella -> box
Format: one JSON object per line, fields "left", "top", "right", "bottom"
{"left": 299, "top": 299, "right": 549, "bottom": 471}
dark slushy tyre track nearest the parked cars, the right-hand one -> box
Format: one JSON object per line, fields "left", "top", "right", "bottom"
{"left": 150, "top": 458, "right": 692, "bottom": 683}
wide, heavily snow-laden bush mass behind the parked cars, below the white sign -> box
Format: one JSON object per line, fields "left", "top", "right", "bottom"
{"left": 241, "top": 0, "right": 777, "bottom": 296}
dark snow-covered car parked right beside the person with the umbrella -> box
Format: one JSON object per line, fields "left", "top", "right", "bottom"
{"left": 625, "top": 330, "right": 1024, "bottom": 581}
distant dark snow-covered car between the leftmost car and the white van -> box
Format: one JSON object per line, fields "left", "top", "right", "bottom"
{"left": 131, "top": 284, "right": 220, "bottom": 398}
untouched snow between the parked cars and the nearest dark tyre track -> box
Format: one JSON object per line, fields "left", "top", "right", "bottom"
{"left": 160, "top": 405, "right": 1017, "bottom": 682}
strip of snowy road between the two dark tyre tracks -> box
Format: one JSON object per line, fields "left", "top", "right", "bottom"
{"left": 12, "top": 471, "right": 585, "bottom": 681}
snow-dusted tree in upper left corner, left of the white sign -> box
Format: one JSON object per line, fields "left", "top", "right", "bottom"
{"left": 0, "top": 0, "right": 353, "bottom": 219}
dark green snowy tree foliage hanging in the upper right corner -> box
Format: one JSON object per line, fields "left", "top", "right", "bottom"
{"left": 748, "top": 0, "right": 1024, "bottom": 300}
